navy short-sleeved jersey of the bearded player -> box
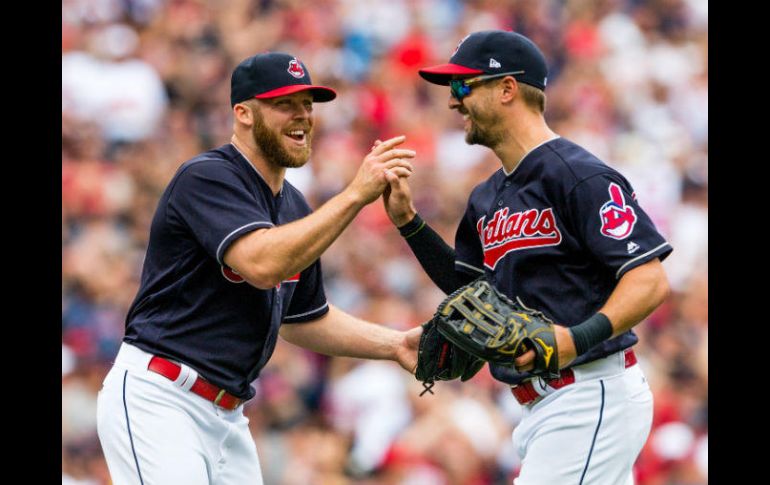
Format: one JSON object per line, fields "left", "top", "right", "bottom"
{"left": 124, "top": 144, "right": 329, "bottom": 399}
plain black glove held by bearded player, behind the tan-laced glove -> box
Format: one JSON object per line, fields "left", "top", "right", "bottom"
{"left": 414, "top": 320, "right": 484, "bottom": 396}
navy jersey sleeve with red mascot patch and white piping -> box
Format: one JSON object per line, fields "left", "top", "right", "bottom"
{"left": 567, "top": 173, "right": 673, "bottom": 279}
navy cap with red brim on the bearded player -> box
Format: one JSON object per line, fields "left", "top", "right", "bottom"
{"left": 230, "top": 52, "right": 337, "bottom": 106}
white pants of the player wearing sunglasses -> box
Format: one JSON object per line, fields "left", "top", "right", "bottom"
{"left": 513, "top": 352, "right": 652, "bottom": 485}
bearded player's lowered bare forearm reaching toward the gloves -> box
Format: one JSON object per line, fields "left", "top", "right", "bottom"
{"left": 281, "top": 305, "right": 404, "bottom": 360}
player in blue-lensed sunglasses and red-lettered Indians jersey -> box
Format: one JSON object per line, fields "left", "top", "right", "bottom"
{"left": 384, "top": 31, "right": 672, "bottom": 485}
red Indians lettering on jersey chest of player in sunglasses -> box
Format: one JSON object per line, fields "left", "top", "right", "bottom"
{"left": 476, "top": 207, "right": 561, "bottom": 269}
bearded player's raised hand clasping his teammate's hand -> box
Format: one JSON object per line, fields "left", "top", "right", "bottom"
{"left": 346, "top": 135, "right": 416, "bottom": 204}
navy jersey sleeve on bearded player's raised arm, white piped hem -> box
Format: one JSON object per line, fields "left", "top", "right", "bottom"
{"left": 169, "top": 161, "right": 273, "bottom": 266}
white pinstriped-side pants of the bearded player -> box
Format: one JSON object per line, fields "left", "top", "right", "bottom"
{"left": 97, "top": 343, "right": 262, "bottom": 485}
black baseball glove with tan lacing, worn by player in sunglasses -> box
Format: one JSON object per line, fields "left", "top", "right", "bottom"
{"left": 433, "top": 278, "right": 559, "bottom": 379}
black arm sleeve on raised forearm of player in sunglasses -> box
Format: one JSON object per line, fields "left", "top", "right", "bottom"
{"left": 399, "top": 215, "right": 474, "bottom": 294}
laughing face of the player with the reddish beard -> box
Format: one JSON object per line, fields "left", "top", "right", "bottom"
{"left": 247, "top": 91, "right": 313, "bottom": 168}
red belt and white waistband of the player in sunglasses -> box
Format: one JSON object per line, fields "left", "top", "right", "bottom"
{"left": 511, "top": 348, "right": 636, "bottom": 405}
